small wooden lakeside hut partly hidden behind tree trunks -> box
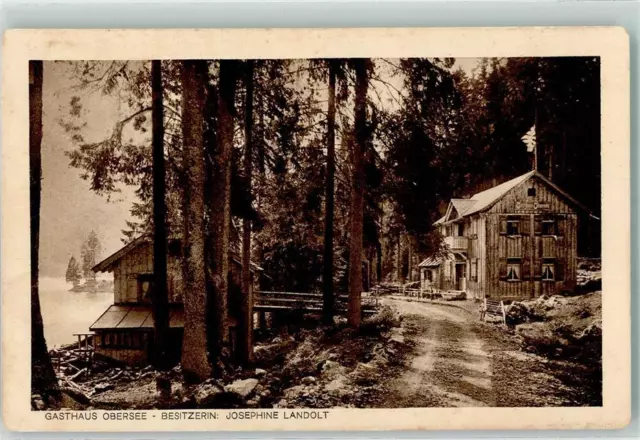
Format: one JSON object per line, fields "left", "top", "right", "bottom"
{"left": 89, "top": 236, "right": 262, "bottom": 365}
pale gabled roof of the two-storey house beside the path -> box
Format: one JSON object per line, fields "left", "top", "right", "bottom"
{"left": 434, "top": 170, "right": 589, "bottom": 225}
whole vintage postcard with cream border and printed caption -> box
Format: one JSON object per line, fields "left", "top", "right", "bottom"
{"left": 2, "top": 27, "right": 631, "bottom": 431}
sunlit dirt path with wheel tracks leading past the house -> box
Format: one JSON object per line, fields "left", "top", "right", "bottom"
{"left": 381, "top": 299, "right": 594, "bottom": 408}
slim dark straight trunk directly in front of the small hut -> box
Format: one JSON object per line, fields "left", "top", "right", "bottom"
{"left": 151, "top": 60, "right": 169, "bottom": 368}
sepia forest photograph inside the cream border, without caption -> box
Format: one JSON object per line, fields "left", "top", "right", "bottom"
{"left": 30, "top": 57, "right": 602, "bottom": 410}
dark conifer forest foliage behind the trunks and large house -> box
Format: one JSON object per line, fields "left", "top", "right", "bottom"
{"left": 58, "top": 57, "right": 600, "bottom": 291}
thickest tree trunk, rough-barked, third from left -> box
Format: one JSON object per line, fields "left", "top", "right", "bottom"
{"left": 182, "top": 61, "right": 211, "bottom": 381}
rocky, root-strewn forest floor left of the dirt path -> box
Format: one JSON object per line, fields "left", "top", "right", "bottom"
{"left": 37, "top": 307, "right": 410, "bottom": 410}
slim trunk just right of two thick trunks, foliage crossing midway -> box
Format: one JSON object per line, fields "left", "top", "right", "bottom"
{"left": 238, "top": 60, "right": 254, "bottom": 364}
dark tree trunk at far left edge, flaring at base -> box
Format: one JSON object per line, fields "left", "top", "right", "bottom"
{"left": 29, "top": 61, "right": 59, "bottom": 399}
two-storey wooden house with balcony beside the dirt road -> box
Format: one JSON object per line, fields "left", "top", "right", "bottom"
{"left": 419, "top": 171, "right": 588, "bottom": 300}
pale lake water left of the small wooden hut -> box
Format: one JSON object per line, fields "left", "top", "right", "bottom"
{"left": 40, "top": 278, "right": 113, "bottom": 350}
